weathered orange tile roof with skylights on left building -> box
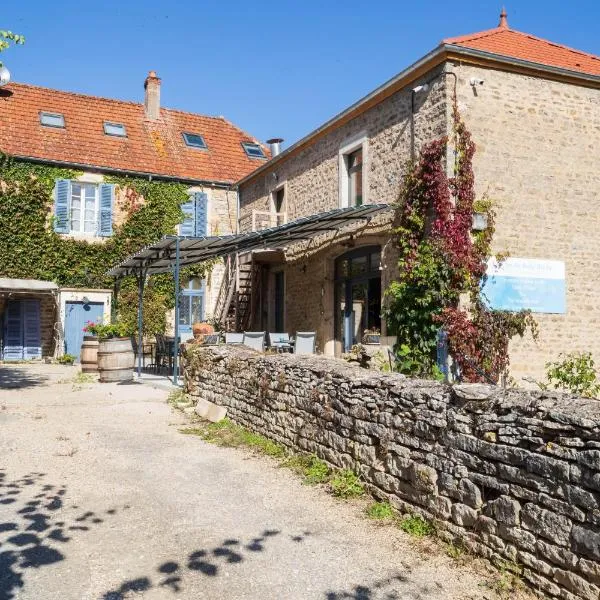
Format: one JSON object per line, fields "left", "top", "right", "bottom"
{"left": 0, "top": 83, "right": 269, "bottom": 182}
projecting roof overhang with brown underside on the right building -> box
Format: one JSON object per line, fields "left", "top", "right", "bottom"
{"left": 235, "top": 43, "right": 600, "bottom": 187}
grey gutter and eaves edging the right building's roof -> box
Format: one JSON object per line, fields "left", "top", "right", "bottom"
{"left": 232, "top": 44, "right": 600, "bottom": 188}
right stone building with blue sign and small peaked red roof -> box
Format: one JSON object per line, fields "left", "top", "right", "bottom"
{"left": 238, "top": 11, "right": 600, "bottom": 378}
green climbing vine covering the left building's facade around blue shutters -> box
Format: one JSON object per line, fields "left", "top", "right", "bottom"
{"left": 0, "top": 156, "right": 214, "bottom": 334}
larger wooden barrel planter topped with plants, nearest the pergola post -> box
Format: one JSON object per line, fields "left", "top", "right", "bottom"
{"left": 86, "top": 321, "right": 135, "bottom": 383}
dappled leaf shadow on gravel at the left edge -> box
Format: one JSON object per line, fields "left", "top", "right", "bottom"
{"left": 0, "top": 469, "right": 117, "bottom": 600}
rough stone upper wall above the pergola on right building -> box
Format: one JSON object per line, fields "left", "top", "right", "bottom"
{"left": 240, "top": 67, "right": 446, "bottom": 232}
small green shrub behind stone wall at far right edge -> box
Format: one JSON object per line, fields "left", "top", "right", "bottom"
{"left": 541, "top": 352, "right": 600, "bottom": 398}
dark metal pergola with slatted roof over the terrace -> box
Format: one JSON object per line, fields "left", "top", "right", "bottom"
{"left": 108, "top": 204, "right": 393, "bottom": 385}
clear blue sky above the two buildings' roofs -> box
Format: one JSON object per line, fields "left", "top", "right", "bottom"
{"left": 0, "top": 0, "right": 600, "bottom": 146}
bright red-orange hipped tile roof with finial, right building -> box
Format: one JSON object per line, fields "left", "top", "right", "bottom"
{"left": 442, "top": 14, "right": 600, "bottom": 75}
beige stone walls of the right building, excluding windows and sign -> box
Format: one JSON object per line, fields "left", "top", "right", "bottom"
{"left": 240, "top": 62, "right": 600, "bottom": 382}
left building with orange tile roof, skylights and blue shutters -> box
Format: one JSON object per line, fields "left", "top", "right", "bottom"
{"left": 0, "top": 71, "right": 269, "bottom": 359}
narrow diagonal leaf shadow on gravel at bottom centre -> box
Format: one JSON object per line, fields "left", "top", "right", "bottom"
{"left": 102, "top": 529, "right": 310, "bottom": 600}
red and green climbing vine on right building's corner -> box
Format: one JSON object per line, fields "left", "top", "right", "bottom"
{"left": 386, "top": 110, "right": 537, "bottom": 382}
